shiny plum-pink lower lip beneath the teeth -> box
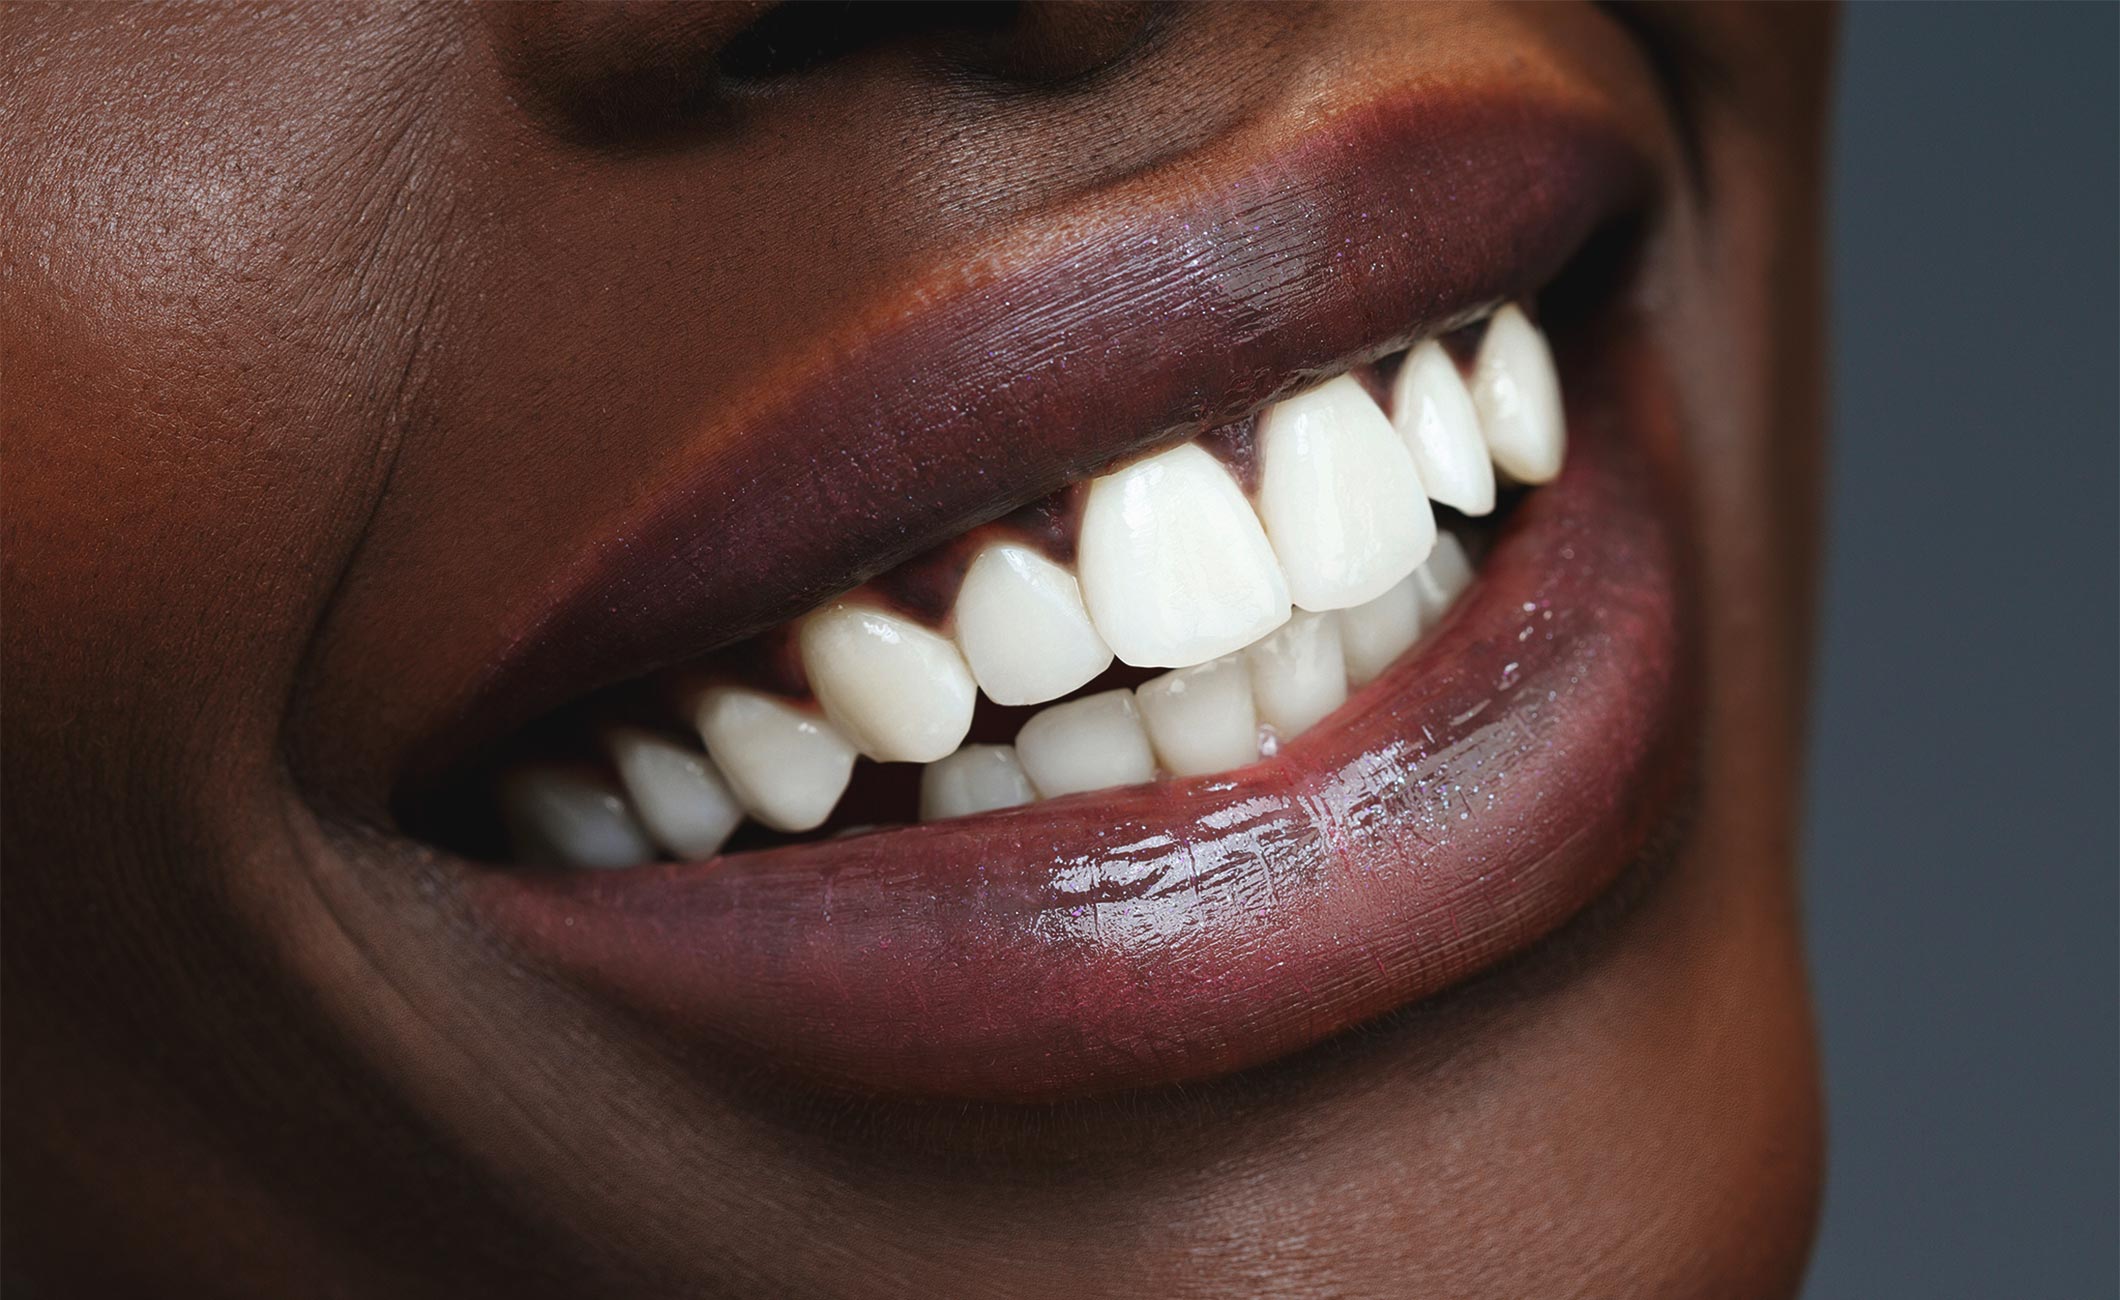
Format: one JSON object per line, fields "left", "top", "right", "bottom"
{"left": 466, "top": 324, "right": 1692, "bottom": 1103}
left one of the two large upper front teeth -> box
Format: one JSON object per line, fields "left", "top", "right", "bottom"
{"left": 1079, "top": 443, "right": 1289, "bottom": 668}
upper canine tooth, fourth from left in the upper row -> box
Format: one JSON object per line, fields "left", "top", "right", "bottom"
{"left": 801, "top": 600, "right": 979, "bottom": 763}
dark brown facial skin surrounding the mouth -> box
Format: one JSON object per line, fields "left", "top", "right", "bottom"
{"left": 0, "top": 4, "right": 1830, "bottom": 1296}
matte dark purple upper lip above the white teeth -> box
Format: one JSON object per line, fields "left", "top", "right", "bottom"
{"left": 401, "top": 95, "right": 1654, "bottom": 789}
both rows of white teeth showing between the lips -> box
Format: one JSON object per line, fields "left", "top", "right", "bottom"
{"left": 496, "top": 305, "right": 1567, "bottom": 867}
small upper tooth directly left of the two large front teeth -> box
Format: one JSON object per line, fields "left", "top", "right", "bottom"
{"left": 956, "top": 543, "right": 1111, "bottom": 704}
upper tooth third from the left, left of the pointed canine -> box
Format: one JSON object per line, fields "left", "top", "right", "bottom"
{"left": 695, "top": 687, "right": 854, "bottom": 831}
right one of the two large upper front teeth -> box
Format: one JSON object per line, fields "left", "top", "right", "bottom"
{"left": 1259, "top": 375, "right": 1435, "bottom": 611}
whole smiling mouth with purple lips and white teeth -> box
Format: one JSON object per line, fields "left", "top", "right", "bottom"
{"left": 396, "top": 78, "right": 1692, "bottom": 1103}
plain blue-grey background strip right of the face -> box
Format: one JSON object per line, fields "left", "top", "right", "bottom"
{"left": 1806, "top": 4, "right": 2120, "bottom": 1300}
